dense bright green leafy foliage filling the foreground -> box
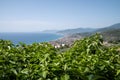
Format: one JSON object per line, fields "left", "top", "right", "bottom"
{"left": 0, "top": 34, "right": 120, "bottom": 80}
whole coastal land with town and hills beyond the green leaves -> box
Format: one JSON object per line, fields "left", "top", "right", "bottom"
{"left": 52, "top": 23, "right": 120, "bottom": 45}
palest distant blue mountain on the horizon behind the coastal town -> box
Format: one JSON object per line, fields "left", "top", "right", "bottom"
{"left": 57, "top": 28, "right": 97, "bottom": 34}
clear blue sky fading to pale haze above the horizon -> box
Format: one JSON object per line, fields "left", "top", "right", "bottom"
{"left": 0, "top": 0, "right": 120, "bottom": 32}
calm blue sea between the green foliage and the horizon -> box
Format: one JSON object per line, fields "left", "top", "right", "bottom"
{"left": 0, "top": 33, "right": 62, "bottom": 44}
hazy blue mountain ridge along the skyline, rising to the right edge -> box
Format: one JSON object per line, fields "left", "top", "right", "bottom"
{"left": 57, "top": 23, "right": 120, "bottom": 35}
